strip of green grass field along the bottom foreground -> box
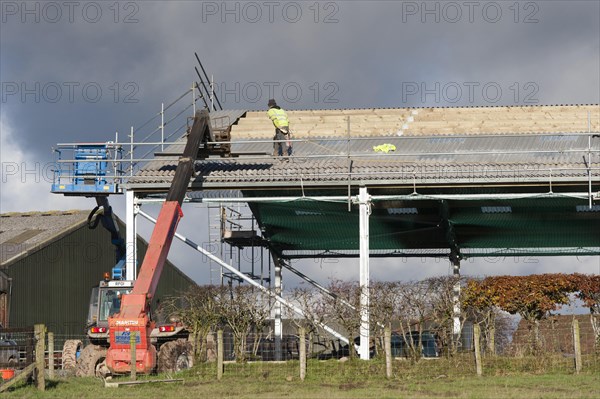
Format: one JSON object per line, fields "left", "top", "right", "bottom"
{"left": 2, "top": 360, "right": 600, "bottom": 399}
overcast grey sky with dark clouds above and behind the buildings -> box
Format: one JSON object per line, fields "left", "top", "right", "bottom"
{"left": 0, "top": 1, "right": 600, "bottom": 290}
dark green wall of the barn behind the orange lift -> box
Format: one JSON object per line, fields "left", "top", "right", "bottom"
{"left": 7, "top": 226, "right": 194, "bottom": 337}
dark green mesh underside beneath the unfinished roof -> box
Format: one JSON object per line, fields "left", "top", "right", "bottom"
{"left": 245, "top": 197, "right": 600, "bottom": 257}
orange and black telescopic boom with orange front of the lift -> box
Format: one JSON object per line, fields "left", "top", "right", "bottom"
{"left": 106, "top": 110, "right": 211, "bottom": 374}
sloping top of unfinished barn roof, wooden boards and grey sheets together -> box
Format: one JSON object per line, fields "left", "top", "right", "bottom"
{"left": 126, "top": 104, "right": 600, "bottom": 192}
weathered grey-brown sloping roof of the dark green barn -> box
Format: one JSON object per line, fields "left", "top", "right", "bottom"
{"left": 0, "top": 210, "right": 88, "bottom": 267}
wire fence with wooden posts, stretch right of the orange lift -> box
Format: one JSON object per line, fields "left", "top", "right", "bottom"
{"left": 190, "top": 325, "right": 600, "bottom": 383}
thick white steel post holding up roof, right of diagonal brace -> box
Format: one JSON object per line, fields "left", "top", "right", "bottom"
{"left": 350, "top": 187, "right": 371, "bottom": 360}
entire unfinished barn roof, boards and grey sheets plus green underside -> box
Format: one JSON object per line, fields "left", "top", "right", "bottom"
{"left": 126, "top": 104, "right": 600, "bottom": 258}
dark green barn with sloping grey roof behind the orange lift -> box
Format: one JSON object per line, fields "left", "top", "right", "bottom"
{"left": 0, "top": 210, "right": 195, "bottom": 338}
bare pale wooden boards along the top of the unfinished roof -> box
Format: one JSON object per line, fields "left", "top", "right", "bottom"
{"left": 232, "top": 104, "right": 600, "bottom": 140}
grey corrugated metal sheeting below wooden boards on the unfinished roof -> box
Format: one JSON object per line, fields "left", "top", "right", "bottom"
{"left": 129, "top": 134, "right": 600, "bottom": 188}
